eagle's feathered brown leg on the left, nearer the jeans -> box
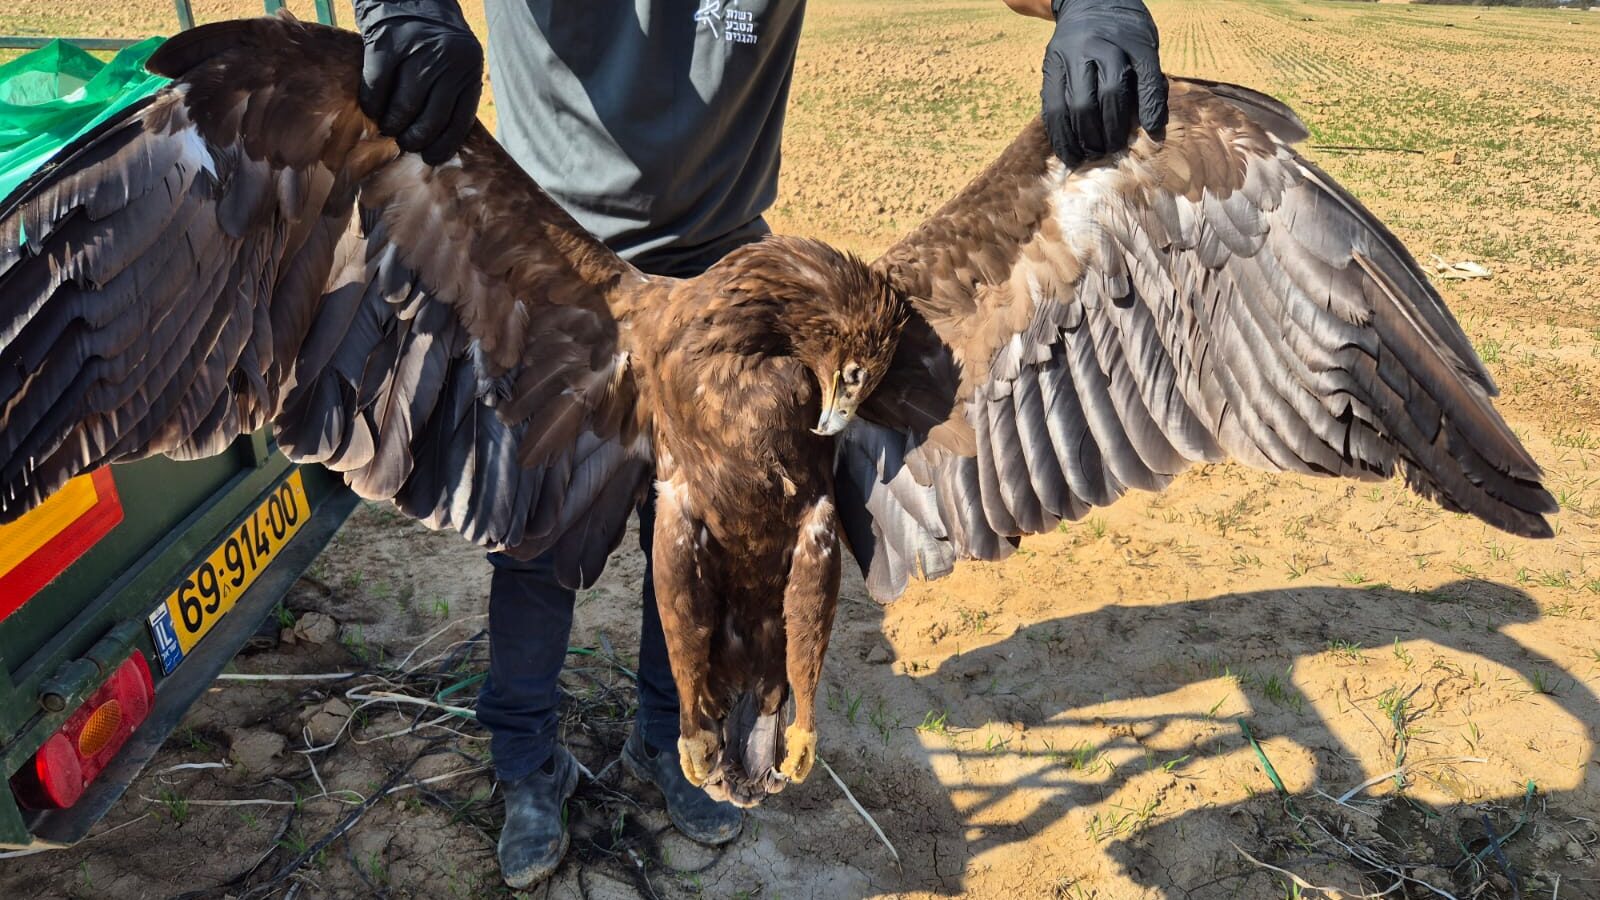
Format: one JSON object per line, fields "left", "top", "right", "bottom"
{"left": 653, "top": 487, "right": 722, "bottom": 786}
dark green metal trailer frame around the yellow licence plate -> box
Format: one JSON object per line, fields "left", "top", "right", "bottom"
{"left": 0, "top": 0, "right": 357, "bottom": 849}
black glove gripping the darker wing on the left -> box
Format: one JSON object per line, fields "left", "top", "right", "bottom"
{"left": 355, "top": 0, "right": 483, "bottom": 165}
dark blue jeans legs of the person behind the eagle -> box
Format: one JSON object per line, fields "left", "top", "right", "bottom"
{"left": 478, "top": 490, "right": 678, "bottom": 781}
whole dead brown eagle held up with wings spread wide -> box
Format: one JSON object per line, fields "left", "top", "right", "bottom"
{"left": 0, "top": 19, "right": 1555, "bottom": 804}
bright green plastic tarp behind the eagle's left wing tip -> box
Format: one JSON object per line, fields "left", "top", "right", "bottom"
{"left": 0, "top": 37, "right": 166, "bottom": 197}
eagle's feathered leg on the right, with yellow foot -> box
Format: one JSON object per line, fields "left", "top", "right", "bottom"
{"left": 778, "top": 496, "right": 840, "bottom": 781}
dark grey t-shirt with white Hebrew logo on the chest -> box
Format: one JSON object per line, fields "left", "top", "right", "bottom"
{"left": 488, "top": 0, "right": 805, "bottom": 274}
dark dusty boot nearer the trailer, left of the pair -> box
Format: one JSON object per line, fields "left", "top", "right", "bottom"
{"left": 499, "top": 745, "right": 578, "bottom": 890}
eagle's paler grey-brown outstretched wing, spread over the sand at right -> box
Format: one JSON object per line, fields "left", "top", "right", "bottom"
{"left": 838, "top": 78, "right": 1555, "bottom": 597}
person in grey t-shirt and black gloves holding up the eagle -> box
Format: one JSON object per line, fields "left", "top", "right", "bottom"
{"left": 355, "top": 0, "right": 1166, "bottom": 889}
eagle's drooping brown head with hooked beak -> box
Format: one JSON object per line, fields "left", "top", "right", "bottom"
{"left": 710, "top": 235, "right": 907, "bottom": 434}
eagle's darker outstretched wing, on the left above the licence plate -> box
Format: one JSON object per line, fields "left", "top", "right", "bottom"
{"left": 0, "top": 19, "right": 650, "bottom": 583}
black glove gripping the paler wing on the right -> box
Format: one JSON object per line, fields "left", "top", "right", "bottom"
{"left": 1042, "top": 0, "right": 1166, "bottom": 165}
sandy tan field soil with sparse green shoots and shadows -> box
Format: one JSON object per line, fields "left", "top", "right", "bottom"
{"left": 0, "top": 0, "right": 1600, "bottom": 898}
